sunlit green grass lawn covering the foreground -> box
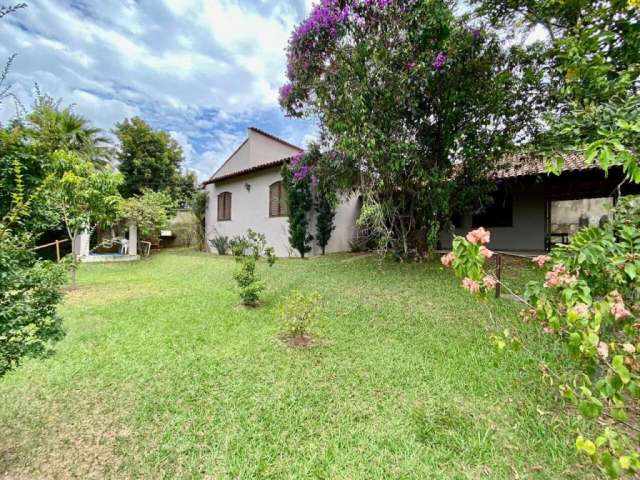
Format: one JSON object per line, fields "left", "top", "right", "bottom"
{"left": 0, "top": 252, "right": 591, "bottom": 479}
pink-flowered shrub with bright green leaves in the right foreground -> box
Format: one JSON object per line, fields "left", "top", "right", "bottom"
{"left": 441, "top": 197, "right": 640, "bottom": 478}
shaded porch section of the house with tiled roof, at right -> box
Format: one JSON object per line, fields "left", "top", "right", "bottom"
{"left": 440, "top": 154, "right": 640, "bottom": 252}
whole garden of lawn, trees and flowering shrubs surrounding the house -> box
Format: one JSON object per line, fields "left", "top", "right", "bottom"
{"left": 0, "top": 0, "right": 640, "bottom": 479}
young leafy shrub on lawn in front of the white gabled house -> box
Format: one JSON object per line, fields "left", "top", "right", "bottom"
{"left": 229, "top": 229, "right": 276, "bottom": 307}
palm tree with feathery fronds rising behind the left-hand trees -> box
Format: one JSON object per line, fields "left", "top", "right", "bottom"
{"left": 26, "top": 93, "right": 113, "bottom": 165}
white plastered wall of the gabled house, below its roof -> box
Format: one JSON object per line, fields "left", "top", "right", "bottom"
{"left": 206, "top": 167, "right": 359, "bottom": 257}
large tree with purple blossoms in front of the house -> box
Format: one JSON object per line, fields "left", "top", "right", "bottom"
{"left": 280, "top": 0, "right": 541, "bottom": 255}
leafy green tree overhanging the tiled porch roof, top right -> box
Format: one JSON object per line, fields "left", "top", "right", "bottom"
{"left": 472, "top": 0, "right": 640, "bottom": 182}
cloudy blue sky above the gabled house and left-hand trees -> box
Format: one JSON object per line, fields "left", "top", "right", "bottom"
{"left": 0, "top": 0, "right": 316, "bottom": 178}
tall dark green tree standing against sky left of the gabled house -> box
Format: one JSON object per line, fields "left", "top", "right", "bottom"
{"left": 115, "top": 117, "right": 184, "bottom": 200}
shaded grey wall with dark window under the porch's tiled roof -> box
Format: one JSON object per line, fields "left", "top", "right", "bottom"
{"left": 440, "top": 181, "right": 545, "bottom": 252}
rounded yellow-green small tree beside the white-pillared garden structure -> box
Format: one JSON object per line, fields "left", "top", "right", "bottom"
{"left": 119, "top": 188, "right": 175, "bottom": 241}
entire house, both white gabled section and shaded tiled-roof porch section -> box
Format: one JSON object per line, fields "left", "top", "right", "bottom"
{"left": 205, "top": 128, "right": 640, "bottom": 257}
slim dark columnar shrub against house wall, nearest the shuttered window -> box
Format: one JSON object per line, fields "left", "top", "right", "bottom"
{"left": 281, "top": 153, "right": 313, "bottom": 258}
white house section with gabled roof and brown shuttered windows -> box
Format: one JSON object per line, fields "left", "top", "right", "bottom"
{"left": 204, "top": 127, "right": 360, "bottom": 257}
